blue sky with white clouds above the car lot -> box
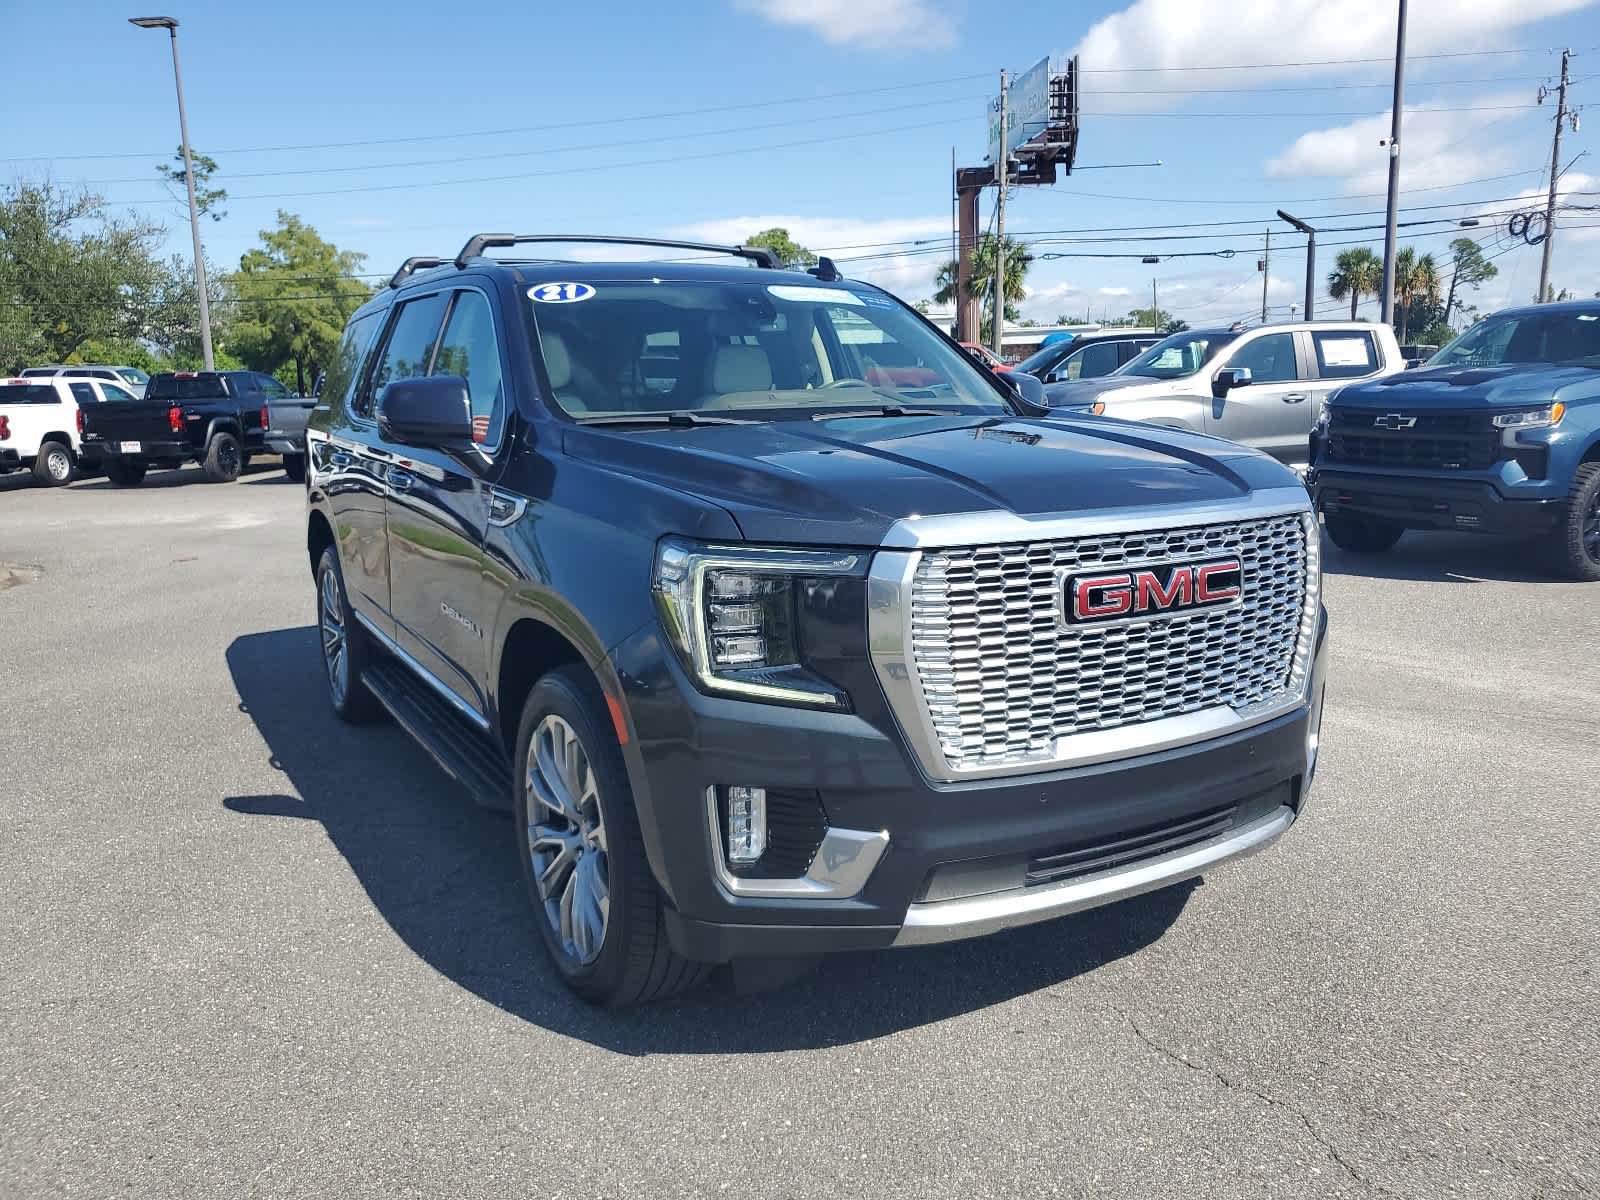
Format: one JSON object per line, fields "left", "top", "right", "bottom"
{"left": 12, "top": 0, "right": 1600, "bottom": 320}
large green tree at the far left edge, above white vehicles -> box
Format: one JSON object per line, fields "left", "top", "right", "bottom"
{"left": 0, "top": 179, "right": 165, "bottom": 371}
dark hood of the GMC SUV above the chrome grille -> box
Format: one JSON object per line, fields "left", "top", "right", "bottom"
{"left": 565, "top": 416, "right": 1298, "bottom": 546}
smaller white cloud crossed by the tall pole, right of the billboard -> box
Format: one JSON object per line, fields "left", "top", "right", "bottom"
{"left": 1266, "top": 94, "right": 1528, "bottom": 194}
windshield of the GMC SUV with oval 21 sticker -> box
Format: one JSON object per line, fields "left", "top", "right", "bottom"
{"left": 528, "top": 278, "right": 1010, "bottom": 421}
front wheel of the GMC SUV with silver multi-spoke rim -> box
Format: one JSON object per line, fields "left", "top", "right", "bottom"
{"left": 514, "top": 666, "right": 710, "bottom": 1008}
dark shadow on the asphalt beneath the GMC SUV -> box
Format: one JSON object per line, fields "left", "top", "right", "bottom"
{"left": 222, "top": 626, "right": 1198, "bottom": 1054}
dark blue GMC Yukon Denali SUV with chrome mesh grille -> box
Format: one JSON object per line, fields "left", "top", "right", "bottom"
{"left": 307, "top": 235, "right": 1326, "bottom": 1005}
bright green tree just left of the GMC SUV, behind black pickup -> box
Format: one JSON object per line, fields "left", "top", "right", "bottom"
{"left": 229, "top": 210, "right": 371, "bottom": 392}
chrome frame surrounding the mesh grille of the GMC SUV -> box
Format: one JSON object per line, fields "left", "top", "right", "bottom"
{"left": 867, "top": 486, "right": 1322, "bottom": 782}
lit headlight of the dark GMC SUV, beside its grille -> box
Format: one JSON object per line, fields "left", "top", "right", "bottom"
{"left": 654, "top": 538, "right": 862, "bottom": 709}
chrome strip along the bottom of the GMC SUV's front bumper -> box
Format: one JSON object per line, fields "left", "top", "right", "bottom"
{"left": 894, "top": 805, "right": 1294, "bottom": 946}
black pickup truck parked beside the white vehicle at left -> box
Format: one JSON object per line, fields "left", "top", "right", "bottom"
{"left": 82, "top": 371, "right": 282, "bottom": 486}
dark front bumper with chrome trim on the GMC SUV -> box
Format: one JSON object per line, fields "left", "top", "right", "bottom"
{"left": 613, "top": 619, "right": 1326, "bottom": 962}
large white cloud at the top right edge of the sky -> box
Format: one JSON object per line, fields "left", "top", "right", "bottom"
{"left": 1075, "top": 0, "right": 1597, "bottom": 110}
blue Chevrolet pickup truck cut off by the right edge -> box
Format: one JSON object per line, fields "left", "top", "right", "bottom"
{"left": 1306, "top": 301, "right": 1600, "bottom": 581}
